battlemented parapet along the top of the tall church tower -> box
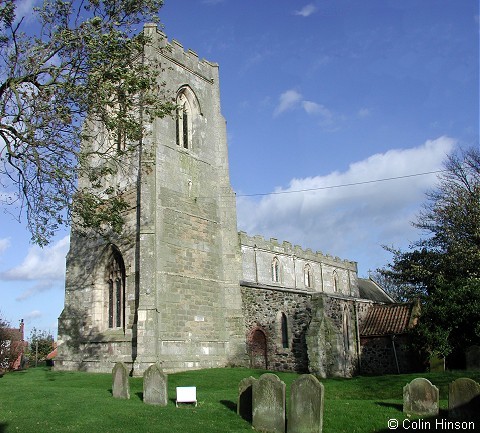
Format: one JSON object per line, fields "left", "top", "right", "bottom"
{"left": 143, "top": 23, "right": 218, "bottom": 83}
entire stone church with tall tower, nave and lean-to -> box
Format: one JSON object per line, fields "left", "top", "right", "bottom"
{"left": 55, "top": 24, "right": 418, "bottom": 377}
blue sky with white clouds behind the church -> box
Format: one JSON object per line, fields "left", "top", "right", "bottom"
{"left": 0, "top": 0, "right": 479, "bottom": 336}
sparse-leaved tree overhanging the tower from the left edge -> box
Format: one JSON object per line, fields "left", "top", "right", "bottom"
{"left": 0, "top": 0, "right": 174, "bottom": 246}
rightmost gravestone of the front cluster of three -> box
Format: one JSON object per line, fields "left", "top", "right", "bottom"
{"left": 287, "top": 374, "right": 324, "bottom": 433}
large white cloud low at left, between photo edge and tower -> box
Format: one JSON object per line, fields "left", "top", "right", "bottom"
{"left": 0, "top": 236, "right": 70, "bottom": 281}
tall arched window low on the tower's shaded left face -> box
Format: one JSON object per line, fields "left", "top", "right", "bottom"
{"left": 106, "top": 248, "right": 125, "bottom": 328}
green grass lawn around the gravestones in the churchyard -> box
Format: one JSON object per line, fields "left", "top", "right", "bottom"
{"left": 0, "top": 367, "right": 480, "bottom": 433}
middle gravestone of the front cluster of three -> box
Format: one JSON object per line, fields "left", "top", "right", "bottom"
{"left": 252, "top": 373, "right": 285, "bottom": 433}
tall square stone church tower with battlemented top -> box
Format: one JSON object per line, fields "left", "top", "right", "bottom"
{"left": 56, "top": 25, "right": 245, "bottom": 374}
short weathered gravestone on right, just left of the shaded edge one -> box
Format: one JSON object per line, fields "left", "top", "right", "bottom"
{"left": 403, "top": 377, "right": 439, "bottom": 416}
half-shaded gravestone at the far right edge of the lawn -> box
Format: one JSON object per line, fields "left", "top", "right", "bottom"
{"left": 448, "top": 377, "right": 480, "bottom": 420}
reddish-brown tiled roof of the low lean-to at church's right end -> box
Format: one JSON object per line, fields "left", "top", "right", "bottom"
{"left": 360, "top": 303, "right": 414, "bottom": 337}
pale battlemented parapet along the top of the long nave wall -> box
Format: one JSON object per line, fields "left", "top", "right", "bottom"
{"left": 238, "top": 232, "right": 357, "bottom": 270}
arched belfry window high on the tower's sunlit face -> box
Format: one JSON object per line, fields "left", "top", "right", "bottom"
{"left": 176, "top": 86, "right": 199, "bottom": 149}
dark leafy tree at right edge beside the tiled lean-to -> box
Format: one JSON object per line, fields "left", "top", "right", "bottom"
{"left": 379, "top": 149, "right": 480, "bottom": 366}
